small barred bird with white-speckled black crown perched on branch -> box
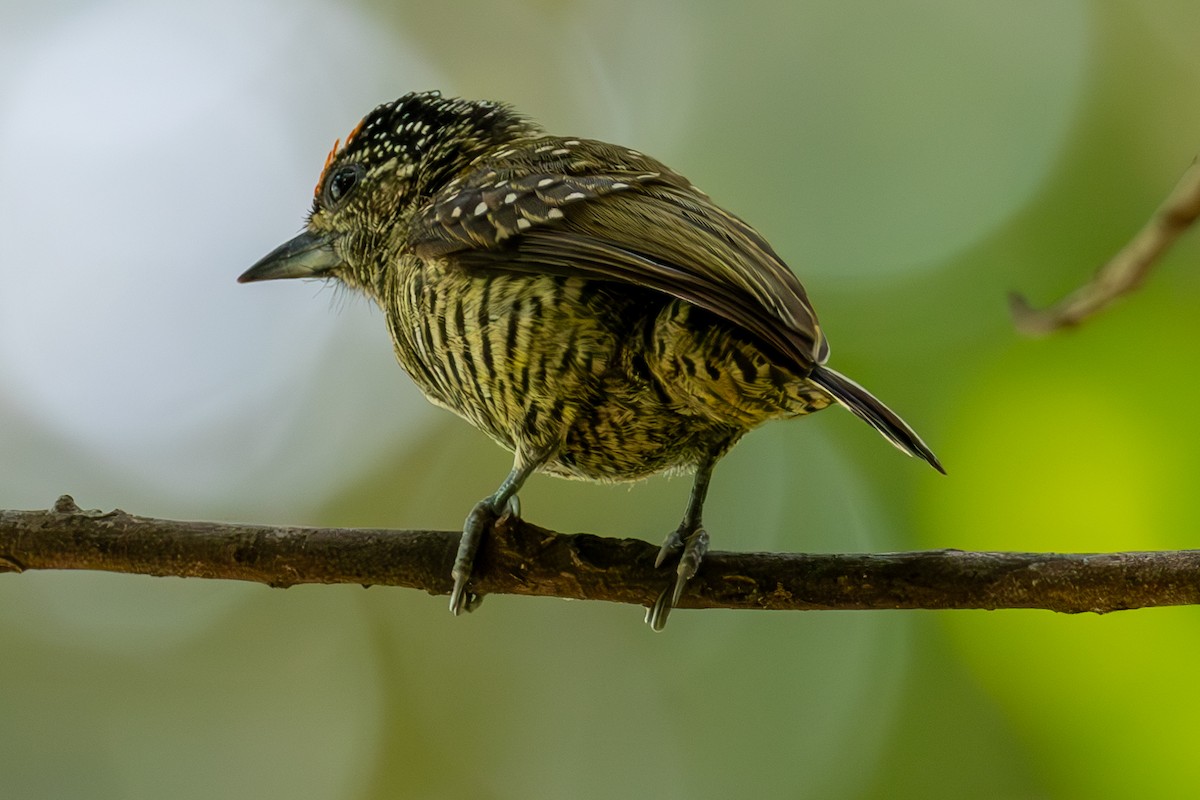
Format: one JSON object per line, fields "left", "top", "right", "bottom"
{"left": 238, "top": 91, "right": 944, "bottom": 631}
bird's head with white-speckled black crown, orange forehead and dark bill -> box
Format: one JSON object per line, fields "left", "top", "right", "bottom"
{"left": 238, "top": 91, "right": 538, "bottom": 294}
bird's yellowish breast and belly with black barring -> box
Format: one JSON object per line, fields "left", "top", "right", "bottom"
{"left": 388, "top": 258, "right": 829, "bottom": 481}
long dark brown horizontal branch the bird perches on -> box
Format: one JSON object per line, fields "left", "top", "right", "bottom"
{"left": 0, "top": 495, "right": 1200, "bottom": 613}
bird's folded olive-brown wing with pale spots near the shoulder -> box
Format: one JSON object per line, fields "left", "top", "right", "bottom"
{"left": 409, "top": 139, "right": 828, "bottom": 372}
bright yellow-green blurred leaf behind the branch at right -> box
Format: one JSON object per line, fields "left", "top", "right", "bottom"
{"left": 920, "top": 283, "right": 1200, "bottom": 798}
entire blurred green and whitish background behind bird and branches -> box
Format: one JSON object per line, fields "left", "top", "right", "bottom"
{"left": 0, "top": 0, "right": 1200, "bottom": 800}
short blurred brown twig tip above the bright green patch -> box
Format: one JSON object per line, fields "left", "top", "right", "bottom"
{"left": 1008, "top": 152, "right": 1200, "bottom": 336}
